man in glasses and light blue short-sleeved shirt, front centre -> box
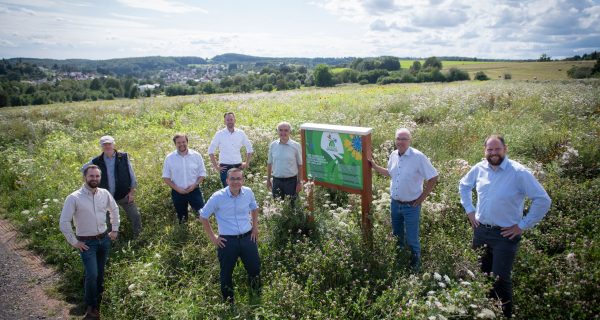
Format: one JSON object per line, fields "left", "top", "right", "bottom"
{"left": 198, "top": 168, "right": 260, "bottom": 303}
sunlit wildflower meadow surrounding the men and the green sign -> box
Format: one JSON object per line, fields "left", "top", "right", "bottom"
{"left": 0, "top": 79, "right": 600, "bottom": 319}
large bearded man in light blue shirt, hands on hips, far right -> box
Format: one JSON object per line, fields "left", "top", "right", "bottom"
{"left": 459, "top": 135, "right": 551, "bottom": 318}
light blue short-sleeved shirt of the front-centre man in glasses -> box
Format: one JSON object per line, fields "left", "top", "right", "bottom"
{"left": 198, "top": 187, "right": 258, "bottom": 236}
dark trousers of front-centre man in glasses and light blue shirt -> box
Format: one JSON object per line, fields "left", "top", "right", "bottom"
{"left": 217, "top": 234, "right": 260, "bottom": 303}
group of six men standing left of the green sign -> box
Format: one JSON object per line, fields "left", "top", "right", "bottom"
{"left": 60, "top": 112, "right": 302, "bottom": 319}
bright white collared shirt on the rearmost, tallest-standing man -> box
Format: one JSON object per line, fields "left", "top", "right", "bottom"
{"left": 208, "top": 128, "right": 254, "bottom": 164}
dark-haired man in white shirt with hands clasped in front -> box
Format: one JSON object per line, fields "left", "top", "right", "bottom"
{"left": 162, "top": 133, "right": 206, "bottom": 223}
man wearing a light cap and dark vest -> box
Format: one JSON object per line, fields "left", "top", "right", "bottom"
{"left": 82, "top": 136, "right": 142, "bottom": 238}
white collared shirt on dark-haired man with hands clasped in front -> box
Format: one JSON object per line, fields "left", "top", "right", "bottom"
{"left": 162, "top": 149, "right": 206, "bottom": 188}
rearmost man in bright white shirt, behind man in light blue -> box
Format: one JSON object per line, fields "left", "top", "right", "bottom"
{"left": 208, "top": 112, "right": 254, "bottom": 187}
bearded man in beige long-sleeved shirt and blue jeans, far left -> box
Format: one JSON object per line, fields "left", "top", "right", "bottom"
{"left": 59, "top": 164, "right": 119, "bottom": 319}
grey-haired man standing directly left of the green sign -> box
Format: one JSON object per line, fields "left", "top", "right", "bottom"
{"left": 267, "top": 122, "right": 302, "bottom": 199}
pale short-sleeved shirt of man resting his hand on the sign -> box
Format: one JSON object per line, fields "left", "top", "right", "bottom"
{"left": 387, "top": 147, "right": 438, "bottom": 201}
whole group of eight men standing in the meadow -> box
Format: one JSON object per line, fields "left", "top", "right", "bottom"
{"left": 60, "top": 112, "right": 550, "bottom": 318}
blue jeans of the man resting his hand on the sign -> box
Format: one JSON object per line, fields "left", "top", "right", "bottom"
{"left": 391, "top": 200, "right": 421, "bottom": 270}
